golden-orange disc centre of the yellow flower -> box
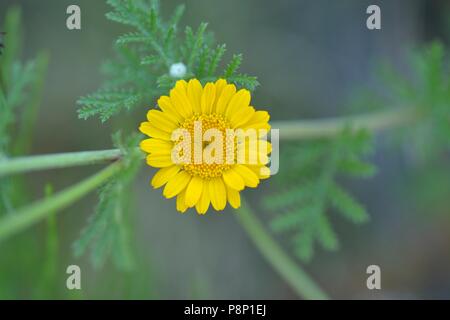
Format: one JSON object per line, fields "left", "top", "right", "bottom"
{"left": 180, "top": 113, "right": 236, "bottom": 179}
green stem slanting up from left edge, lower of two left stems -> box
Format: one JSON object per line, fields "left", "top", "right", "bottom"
{"left": 0, "top": 162, "right": 122, "bottom": 242}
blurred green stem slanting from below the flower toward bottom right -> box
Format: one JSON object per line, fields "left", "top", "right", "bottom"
{"left": 236, "top": 199, "right": 328, "bottom": 300}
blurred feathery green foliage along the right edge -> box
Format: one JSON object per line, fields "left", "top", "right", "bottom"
{"left": 370, "top": 41, "right": 450, "bottom": 220}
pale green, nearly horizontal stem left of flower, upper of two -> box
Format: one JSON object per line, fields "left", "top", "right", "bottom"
{"left": 0, "top": 149, "right": 122, "bottom": 177}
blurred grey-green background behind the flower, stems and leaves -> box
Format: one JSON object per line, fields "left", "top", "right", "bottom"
{"left": 0, "top": 0, "right": 450, "bottom": 299}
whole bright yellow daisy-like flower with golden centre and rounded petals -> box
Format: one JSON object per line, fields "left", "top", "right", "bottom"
{"left": 139, "top": 79, "right": 271, "bottom": 214}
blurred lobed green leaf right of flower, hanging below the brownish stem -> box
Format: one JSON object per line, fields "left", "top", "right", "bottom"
{"left": 263, "top": 130, "right": 375, "bottom": 261}
